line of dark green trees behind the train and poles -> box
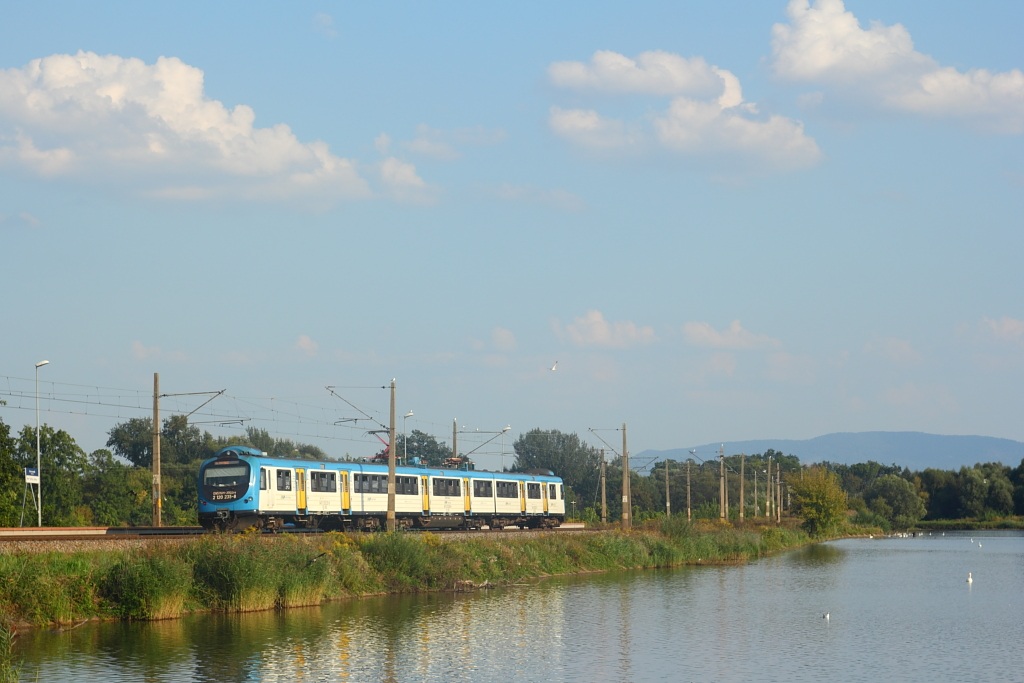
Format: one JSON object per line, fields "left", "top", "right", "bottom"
{"left": 0, "top": 415, "right": 1024, "bottom": 531}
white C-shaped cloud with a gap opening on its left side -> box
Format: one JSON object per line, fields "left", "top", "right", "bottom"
{"left": 548, "top": 50, "right": 821, "bottom": 169}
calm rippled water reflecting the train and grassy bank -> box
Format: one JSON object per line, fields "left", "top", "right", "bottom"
{"left": 17, "top": 532, "right": 1024, "bottom": 683}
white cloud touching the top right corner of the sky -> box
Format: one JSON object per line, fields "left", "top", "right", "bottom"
{"left": 772, "top": 0, "right": 1024, "bottom": 134}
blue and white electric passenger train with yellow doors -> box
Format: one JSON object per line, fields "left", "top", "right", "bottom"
{"left": 199, "top": 445, "right": 565, "bottom": 530}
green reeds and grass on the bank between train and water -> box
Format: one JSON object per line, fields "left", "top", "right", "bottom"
{"left": 0, "top": 519, "right": 810, "bottom": 630}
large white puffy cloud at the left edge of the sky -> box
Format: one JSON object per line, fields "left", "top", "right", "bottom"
{"left": 0, "top": 52, "right": 370, "bottom": 200}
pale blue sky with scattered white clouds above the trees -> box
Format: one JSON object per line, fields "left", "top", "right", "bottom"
{"left": 0, "top": 0, "right": 1024, "bottom": 466}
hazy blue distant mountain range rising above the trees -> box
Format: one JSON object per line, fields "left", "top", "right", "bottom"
{"left": 633, "top": 432, "right": 1024, "bottom": 471}
